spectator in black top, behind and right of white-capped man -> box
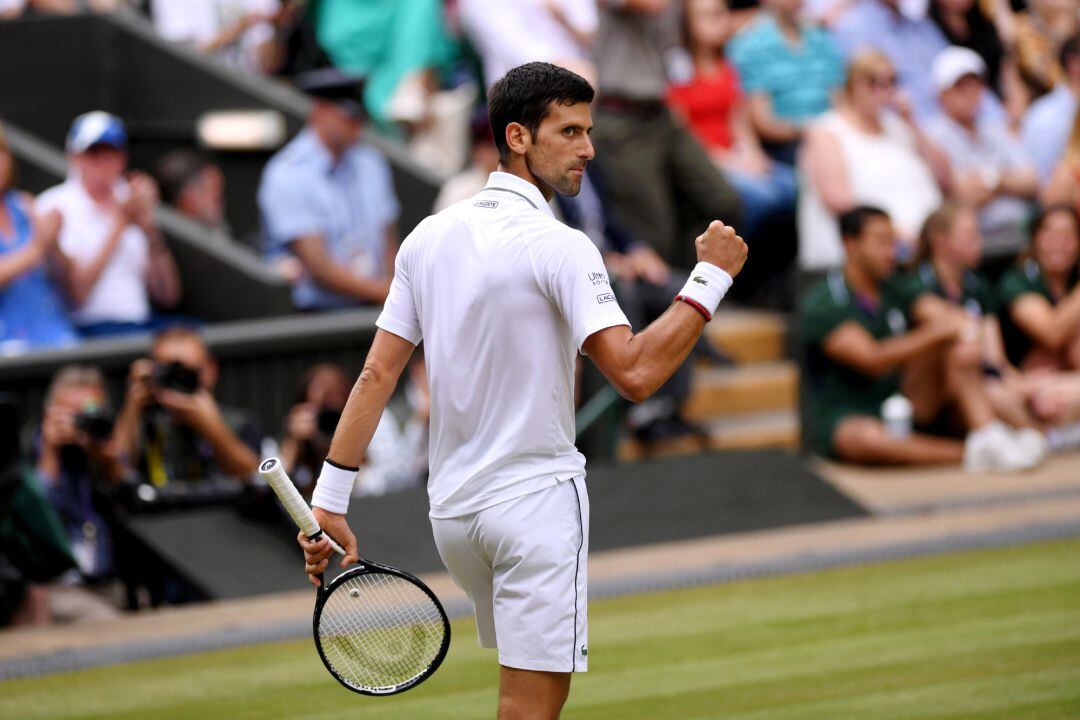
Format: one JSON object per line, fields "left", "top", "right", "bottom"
{"left": 928, "top": 0, "right": 1027, "bottom": 122}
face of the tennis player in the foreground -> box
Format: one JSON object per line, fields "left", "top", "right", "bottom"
{"left": 525, "top": 103, "right": 596, "bottom": 196}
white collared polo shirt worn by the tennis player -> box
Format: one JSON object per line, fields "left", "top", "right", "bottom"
{"left": 376, "top": 173, "right": 630, "bottom": 518}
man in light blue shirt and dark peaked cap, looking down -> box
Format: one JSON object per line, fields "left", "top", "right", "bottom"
{"left": 258, "top": 69, "right": 400, "bottom": 310}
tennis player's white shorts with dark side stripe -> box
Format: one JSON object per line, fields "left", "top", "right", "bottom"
{"left": 431, "top": 477, "right": 589, "bottom": 673}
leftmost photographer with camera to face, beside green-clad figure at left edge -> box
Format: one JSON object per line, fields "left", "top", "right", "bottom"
{"left": 36, "top": 365, "right": 122, "bottom": 620}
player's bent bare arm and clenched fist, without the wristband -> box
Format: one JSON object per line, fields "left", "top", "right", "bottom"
{"left": 583, "top": 220, "right": 746, "bottom": 403}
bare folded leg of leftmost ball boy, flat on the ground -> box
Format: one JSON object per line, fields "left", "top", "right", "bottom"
{"left": 833, "top": 416, "right": 963, "bottom": 465}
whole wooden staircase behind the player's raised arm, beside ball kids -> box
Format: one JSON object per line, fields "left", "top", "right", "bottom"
{"left": 617, "top": 309, "right": 799, "bottom": 461}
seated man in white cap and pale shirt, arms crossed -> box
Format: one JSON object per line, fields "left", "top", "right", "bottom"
{"left": 927, "top": 47, "right": 1039, "bottom": 254}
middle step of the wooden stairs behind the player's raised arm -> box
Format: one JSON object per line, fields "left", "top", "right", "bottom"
{"left": 686, "top": 361, "right": 799, "bottom": 422}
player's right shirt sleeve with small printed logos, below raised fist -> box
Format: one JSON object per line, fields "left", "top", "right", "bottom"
{"left": 530, "top": 230, "right": 630, "bottom": 352}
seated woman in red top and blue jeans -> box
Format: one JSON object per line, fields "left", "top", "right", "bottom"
{"left": 667, "top": 0, "right": 803, "bottom": 240}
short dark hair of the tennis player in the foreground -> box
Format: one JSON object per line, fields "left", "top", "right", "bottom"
{"left": 487, "top": 63, "right": 595, "bottom": 161}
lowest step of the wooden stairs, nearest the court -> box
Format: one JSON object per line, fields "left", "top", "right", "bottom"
{"left": 616, "top": 409, "right": 799, "bottom": 462}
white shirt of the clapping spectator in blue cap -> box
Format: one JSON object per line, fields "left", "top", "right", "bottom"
{"left": 37, "top": 177, "right": 150, "bottom": 325}
